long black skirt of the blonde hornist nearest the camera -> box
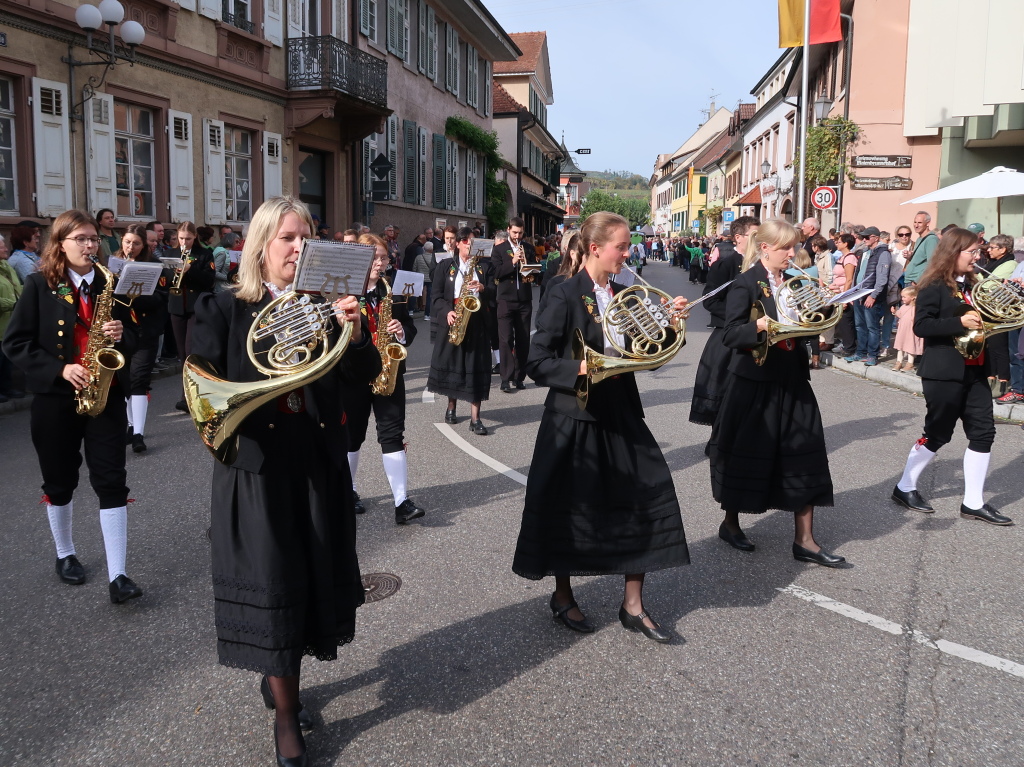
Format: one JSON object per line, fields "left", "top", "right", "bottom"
{"left": 210, "top": 413, "right": 364, "bottom": 676}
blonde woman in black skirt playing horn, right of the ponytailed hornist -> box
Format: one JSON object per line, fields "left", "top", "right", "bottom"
{"left": 708, "top": 219, "right": 848, "bottom": 567}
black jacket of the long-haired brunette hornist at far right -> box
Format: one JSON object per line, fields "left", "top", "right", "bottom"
{"left": 913, "top": 283, "right": 971, "bottom": 381}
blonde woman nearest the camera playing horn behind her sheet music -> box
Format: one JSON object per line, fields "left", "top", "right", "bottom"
{"left": 193, "top": 197, "right": 381, "bottom": 767}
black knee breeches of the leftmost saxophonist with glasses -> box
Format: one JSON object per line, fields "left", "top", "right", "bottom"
{"left": 32, "top": 395, "right": 128, "bottom": 509}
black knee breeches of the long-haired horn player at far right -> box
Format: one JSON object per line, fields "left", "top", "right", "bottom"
{"left": 921, "top": 365, "right": 995, "bottom": 453}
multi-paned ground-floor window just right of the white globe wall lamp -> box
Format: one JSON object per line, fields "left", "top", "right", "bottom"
{"left": 113, "top": 100, "right": 157, "bottom": 218}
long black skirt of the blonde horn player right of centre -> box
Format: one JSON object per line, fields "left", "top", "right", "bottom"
{"left": 708, "top": 376, "right": 834, "bottom": 514}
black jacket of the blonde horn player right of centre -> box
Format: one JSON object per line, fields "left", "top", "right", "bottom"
{"left": 722, "top": 261, "right": 811, "bottom": 381}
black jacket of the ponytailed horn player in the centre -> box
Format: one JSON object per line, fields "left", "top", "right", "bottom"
{"left": 526, "top": 269, "right": 643, "bottom": 421}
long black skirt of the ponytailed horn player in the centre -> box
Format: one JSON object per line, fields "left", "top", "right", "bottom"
{"left": 512, "top": 389, "right": 690, "bottom": 581}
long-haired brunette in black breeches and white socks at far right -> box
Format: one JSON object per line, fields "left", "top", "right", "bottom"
{"left": 892, "top": 228, "right": 1013, "bottom": 525}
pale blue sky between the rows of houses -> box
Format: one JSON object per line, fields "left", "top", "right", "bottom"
{"left": 483, "top": 0, "right": 782, "bottom": 176}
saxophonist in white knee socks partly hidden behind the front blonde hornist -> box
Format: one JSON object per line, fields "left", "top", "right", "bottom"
{"left": 344, "top": 235, "right": 425, "bottom": 524}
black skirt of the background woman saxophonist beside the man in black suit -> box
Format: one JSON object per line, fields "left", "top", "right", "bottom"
{"left": 427, "top": 306, "right": 490, "bottom": 402}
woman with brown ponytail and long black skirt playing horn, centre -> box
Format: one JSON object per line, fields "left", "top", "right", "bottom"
{"left": 512, "top": 213, "right": 690, "bottom": 642}
